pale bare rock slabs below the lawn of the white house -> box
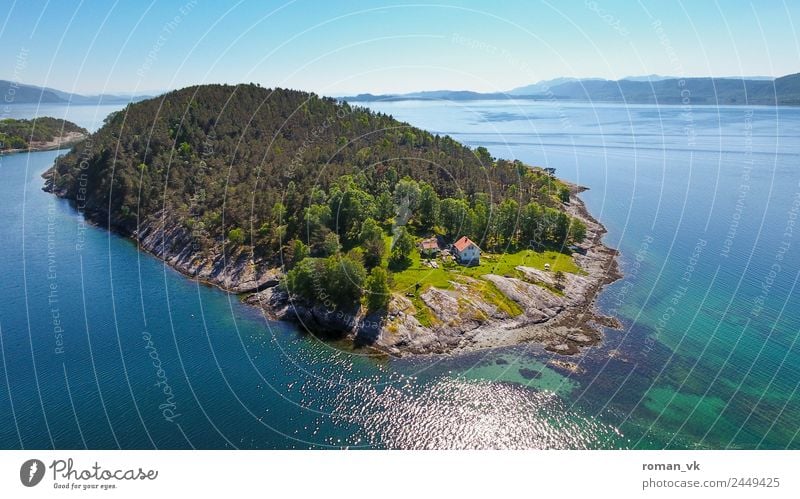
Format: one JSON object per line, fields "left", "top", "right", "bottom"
{"left": 368, "top": 189, "right": 620, "bottom": 358}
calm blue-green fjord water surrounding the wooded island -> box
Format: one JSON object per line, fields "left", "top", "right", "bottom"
{"left": 0, "top": 101, "right": 800, "bottom": 448}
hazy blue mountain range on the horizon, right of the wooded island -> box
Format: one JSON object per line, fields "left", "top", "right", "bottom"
{"left": 341, "top": 73, "right": 800, "bottom": 106}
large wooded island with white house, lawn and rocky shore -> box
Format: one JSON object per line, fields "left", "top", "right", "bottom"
{"left": 44, "top": 84, "right": 619, "bottom": 356}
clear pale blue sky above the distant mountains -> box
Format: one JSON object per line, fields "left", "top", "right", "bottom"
{"left": 0, "top": 0, "right": 800, "bottom": 95}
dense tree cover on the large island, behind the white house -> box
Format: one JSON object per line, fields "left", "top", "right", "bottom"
{"left": 49, "top": 85, "right": 585, "bottom": 307}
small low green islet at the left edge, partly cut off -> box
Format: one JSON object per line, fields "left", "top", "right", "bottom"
{"left": 0, "top": 117, "right": 89, "bottom": 154}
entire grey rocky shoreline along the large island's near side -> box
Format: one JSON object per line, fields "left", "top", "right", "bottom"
{"left": 45, "top": 174, "right": 621, "bottom": 356}
